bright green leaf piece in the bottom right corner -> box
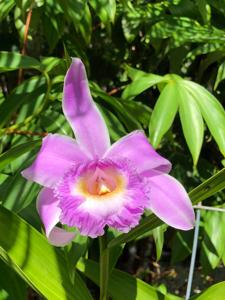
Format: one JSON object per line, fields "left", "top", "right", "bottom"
{"left": 191, "top": 281, "right": 225, "bottom": 300}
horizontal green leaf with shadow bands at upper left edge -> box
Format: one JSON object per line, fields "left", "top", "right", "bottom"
{"left": 0, "top": 51, "right": 41, "bottom": 72}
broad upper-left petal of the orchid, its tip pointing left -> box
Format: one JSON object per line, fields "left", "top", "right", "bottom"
{"left": 22, "top": 134, "right": 88, "bottom": 187}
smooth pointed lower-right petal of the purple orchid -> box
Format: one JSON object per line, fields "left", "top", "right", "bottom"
{"left": 148, "top": 174, "right": 195, "bottom": 230}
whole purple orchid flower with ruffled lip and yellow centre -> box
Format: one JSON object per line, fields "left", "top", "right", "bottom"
{"left": 22, "top": 58, "right": 194, "bottom": 246}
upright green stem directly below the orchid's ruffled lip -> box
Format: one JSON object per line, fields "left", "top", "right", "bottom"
{"left": 99, "top": 234, "right": 109, "bottom": 300}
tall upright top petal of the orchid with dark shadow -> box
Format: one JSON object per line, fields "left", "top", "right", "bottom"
{"left": 63, "top": 58, "right": 110, "bottom": 157}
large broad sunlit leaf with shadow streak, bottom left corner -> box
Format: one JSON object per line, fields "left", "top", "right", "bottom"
{"left": 0, "top": 207, "right": 92, "bottom": 300}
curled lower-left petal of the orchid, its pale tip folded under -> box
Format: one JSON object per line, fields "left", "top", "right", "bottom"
{"left": 37, "top": 188, "right": 75, "bottom": 246}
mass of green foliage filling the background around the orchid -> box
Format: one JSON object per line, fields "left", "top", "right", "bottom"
{"left": 0, "top": 0, "right": 225, "bottom": 300}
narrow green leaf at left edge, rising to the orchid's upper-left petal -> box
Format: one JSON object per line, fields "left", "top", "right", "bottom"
{"left": 0, "top": 140, "right": 41, "bottom": 170}
